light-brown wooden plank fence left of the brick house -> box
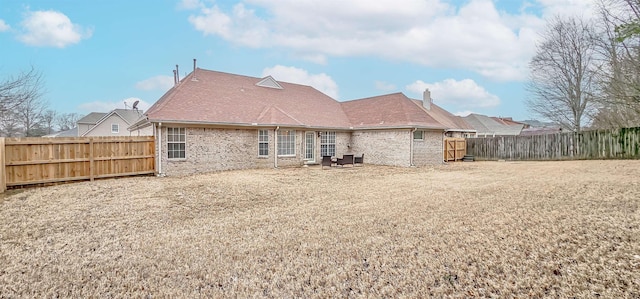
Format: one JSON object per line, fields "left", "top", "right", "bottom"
{"left": 0, "top": 136, "right": 155, "bottom": 192}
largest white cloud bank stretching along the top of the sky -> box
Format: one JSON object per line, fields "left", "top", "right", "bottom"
{"left": 182, "top": 0, "right": 552, "bottom": 81}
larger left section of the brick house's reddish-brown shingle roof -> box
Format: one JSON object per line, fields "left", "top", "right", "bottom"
{"left": 147, "top": 69, "right": 350, "bottom": 128}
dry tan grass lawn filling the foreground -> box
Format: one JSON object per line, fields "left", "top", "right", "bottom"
{"left": 0, "top": 161, "right": 640, "bottom": 298}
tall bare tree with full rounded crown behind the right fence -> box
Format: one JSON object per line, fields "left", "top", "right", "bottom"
{"left": 526, "top": 17, "right": 599, "bottom": 132}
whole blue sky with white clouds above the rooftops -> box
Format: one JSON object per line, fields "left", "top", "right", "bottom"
{"left": 0, "top": 0, "right": 593, "bottom": 120}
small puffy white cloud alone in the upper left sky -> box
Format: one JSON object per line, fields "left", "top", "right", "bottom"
{"left": 18, "top": 10, "right": 92, "bottom": 48}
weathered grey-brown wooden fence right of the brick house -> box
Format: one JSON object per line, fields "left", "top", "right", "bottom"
{"left": 467, "top": 127, "right": 640, "bottom": 160}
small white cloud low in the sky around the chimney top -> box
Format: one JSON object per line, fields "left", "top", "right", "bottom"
{"left": 406, "top": 79, "right": 500, "bottom": 108}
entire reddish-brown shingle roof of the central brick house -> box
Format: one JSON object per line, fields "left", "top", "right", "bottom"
{"left": 134, "top": 68, "right": 473, "bottom": 131}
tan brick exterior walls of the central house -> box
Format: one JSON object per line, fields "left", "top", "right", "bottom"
{"left": 156, "top": 126, "right": 443, "bottom": 175}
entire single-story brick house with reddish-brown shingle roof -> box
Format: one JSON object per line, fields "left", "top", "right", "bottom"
{"left": 130, "top": 69, "right": 471, "bottom": 174}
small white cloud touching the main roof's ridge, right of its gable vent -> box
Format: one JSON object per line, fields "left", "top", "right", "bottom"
{"left": 262, "top": 65, "right": 338, "bottom": 100}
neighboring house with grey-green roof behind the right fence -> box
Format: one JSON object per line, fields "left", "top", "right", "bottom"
{"left": 463, "top": 113, "right": 525, "bottom": 137}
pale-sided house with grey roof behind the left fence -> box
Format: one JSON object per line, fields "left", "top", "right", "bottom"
{"left": 77, "top": 109, "right": 153, "bottom": 137}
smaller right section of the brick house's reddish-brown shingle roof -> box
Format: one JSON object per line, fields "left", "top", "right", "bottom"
{"left": 342, "top": 93, "right": 446, "bottom": 129}
